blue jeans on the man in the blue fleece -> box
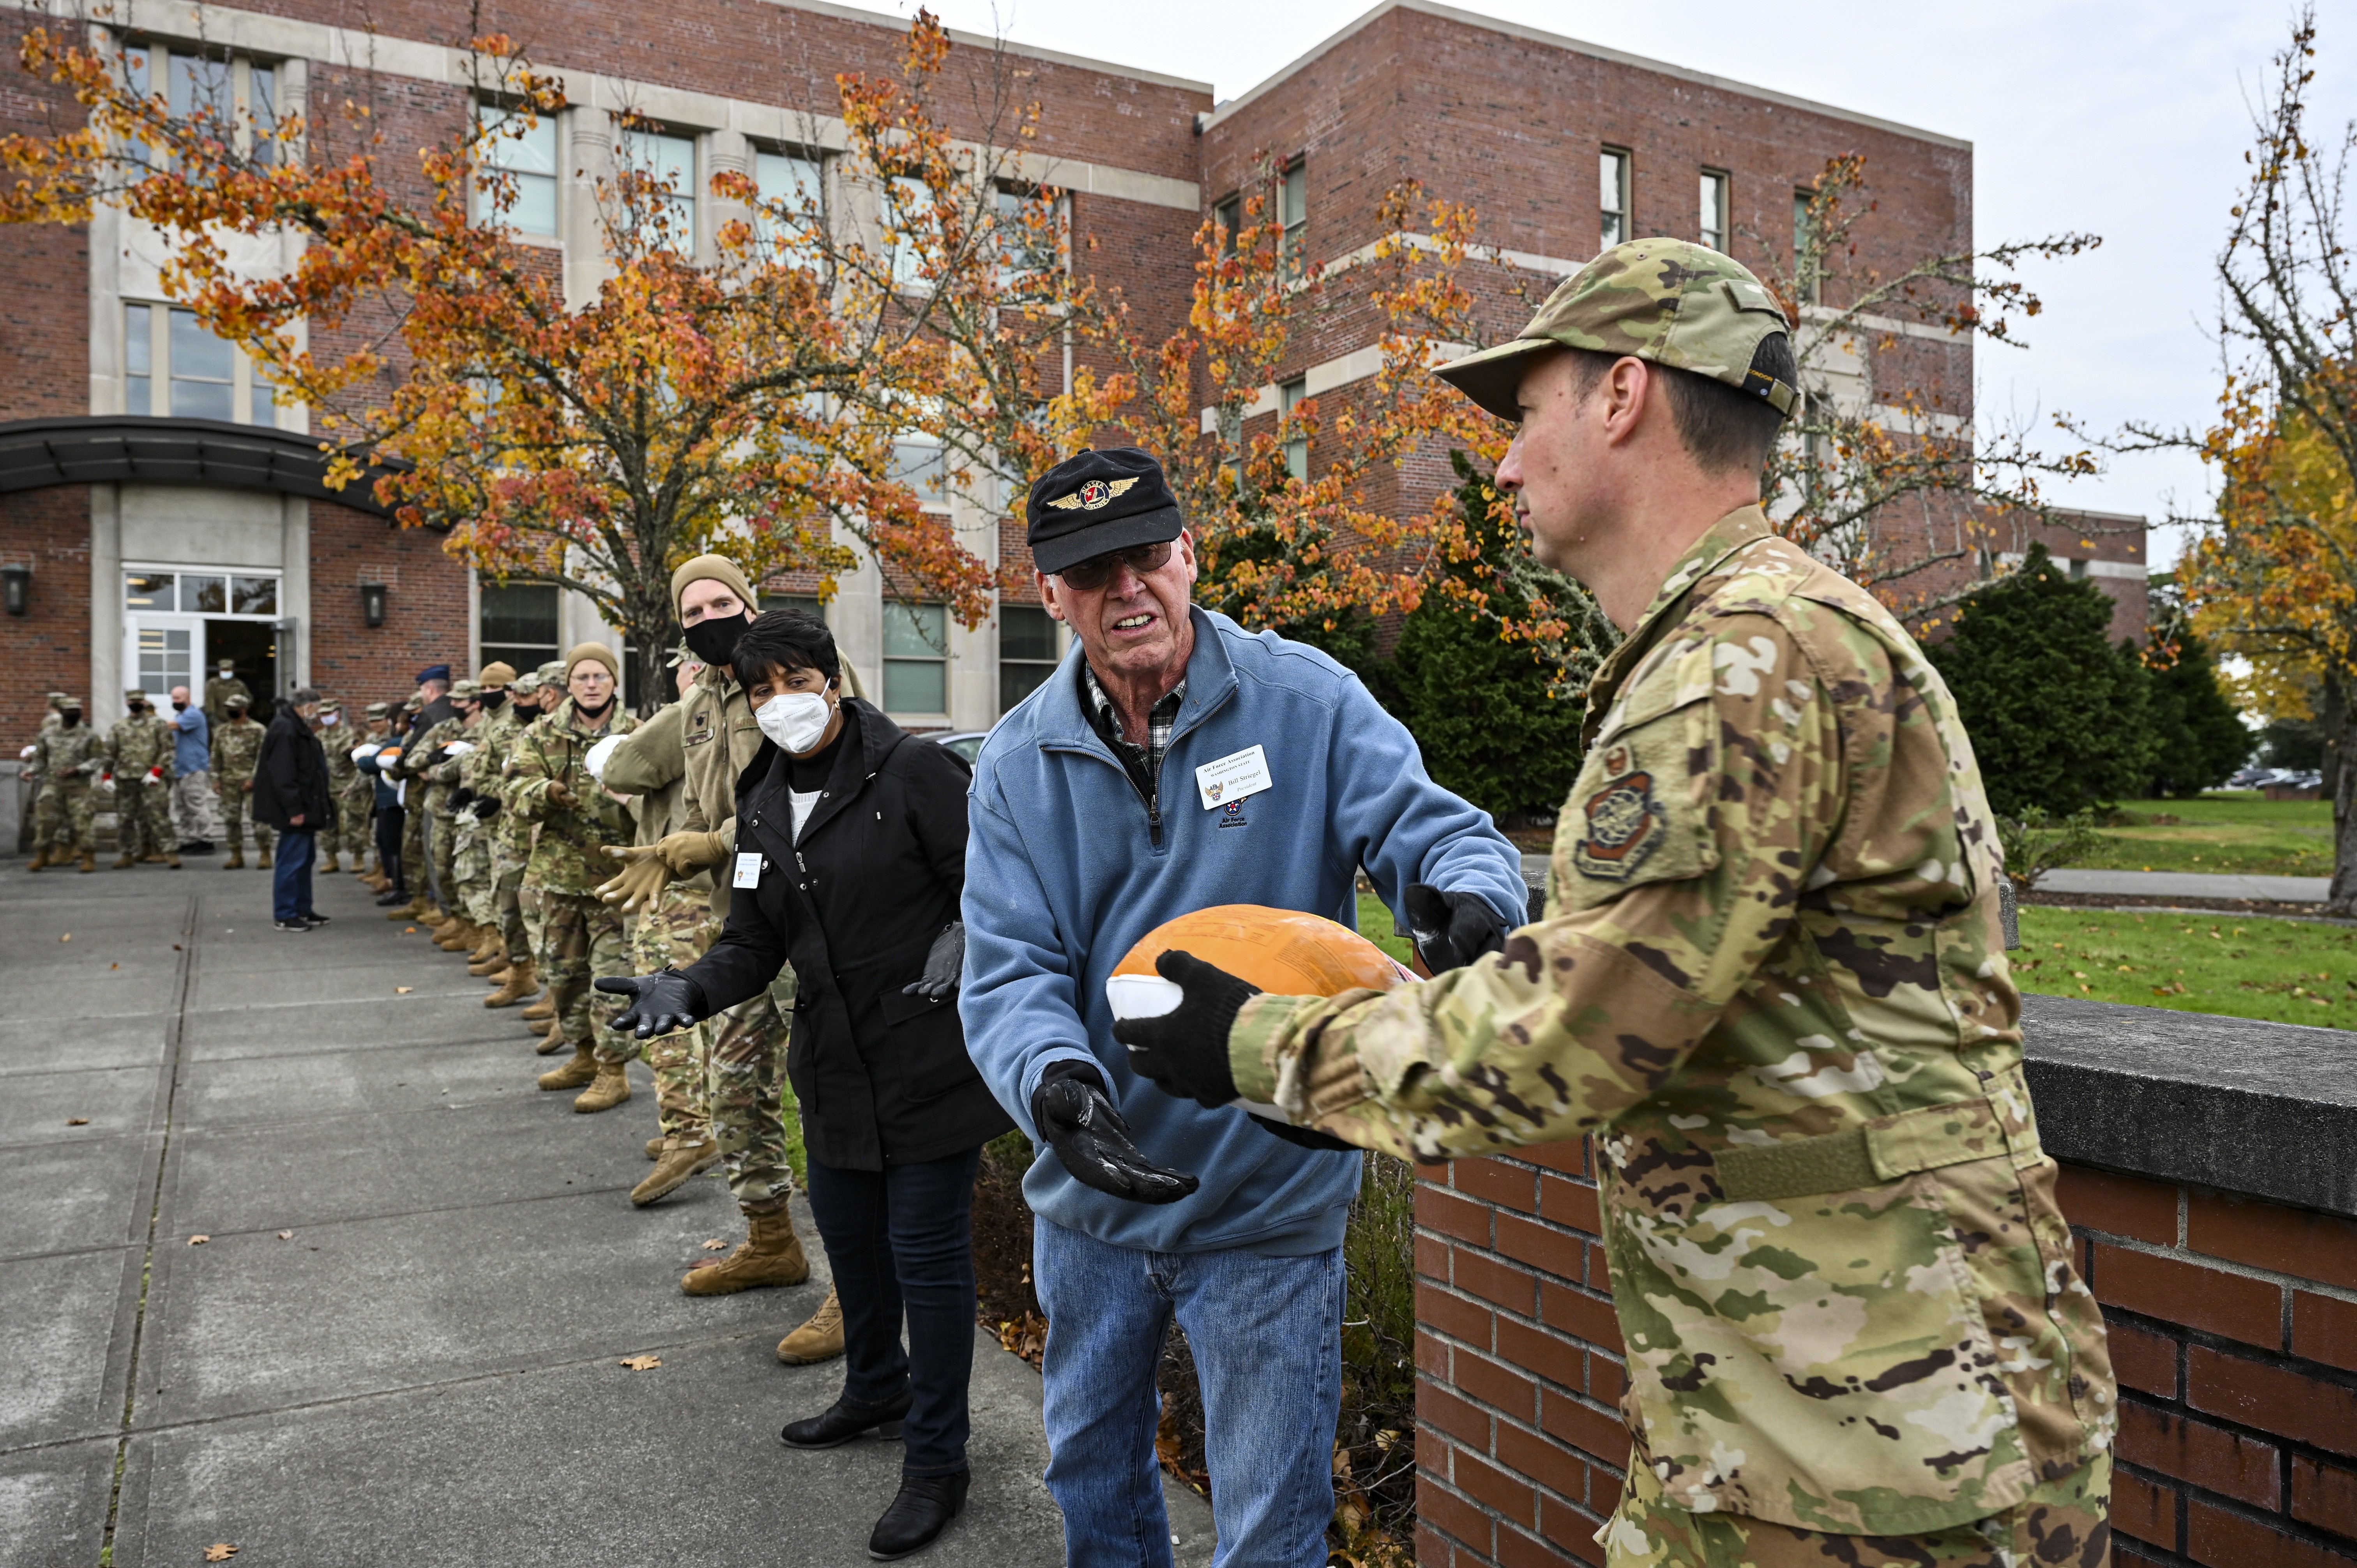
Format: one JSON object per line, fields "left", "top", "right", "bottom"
{"left": 1032, "top": 1219, "right": 1343, "bottom": 1568}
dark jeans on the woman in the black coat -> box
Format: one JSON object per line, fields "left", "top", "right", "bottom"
{"left": 808, "top": 1148, "right": 983, "bottom": 1476}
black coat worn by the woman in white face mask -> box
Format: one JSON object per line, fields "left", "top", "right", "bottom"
{"left": 686, "top": 698, "right": 1014, "bottom": 1169}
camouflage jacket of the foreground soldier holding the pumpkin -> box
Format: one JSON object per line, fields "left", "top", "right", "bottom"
{"left": 1230, "top": 507, "right": 2114, "bottom": 1535}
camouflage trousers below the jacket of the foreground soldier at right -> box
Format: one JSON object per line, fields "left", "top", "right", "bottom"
{"left": 1595, "top": 1455, "right": 2112, "bottom": 1568}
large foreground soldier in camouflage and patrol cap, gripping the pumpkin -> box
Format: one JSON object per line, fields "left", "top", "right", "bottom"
{"left": 1115, "top": 240, "right": 2117, "bottom": 1568}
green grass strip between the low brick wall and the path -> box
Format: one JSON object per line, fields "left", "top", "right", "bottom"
{"left": 2013, "top": 906, "right": 2357, "bottom": 1028}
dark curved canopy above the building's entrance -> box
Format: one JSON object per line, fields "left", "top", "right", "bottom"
{"left": 0, "top": 415, "right": 405, "bottom": 519}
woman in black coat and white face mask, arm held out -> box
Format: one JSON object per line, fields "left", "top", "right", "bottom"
{"left": 599, "top": 611, "right": 1011, "bottom": 1556}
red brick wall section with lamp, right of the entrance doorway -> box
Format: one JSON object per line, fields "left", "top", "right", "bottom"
{"left": 311, "top": 500, "right": 472, "bottom": 703}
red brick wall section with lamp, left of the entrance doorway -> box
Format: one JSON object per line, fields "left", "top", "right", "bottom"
{"left": 0, "top": 486, "right": 94, "bottom": 757}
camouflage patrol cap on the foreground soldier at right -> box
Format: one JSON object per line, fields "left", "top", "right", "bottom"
{"left": 1433, "top": 240, "right": 1801, "bottom": 420}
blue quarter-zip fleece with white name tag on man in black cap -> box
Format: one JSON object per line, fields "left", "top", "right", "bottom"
{"left": 959, "top": 608, "right": 1525, "bottom": 1254}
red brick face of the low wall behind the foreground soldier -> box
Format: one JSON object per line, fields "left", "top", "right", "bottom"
{"left": 1417, "top": 1144, "right": 2357, "bottom": 1568}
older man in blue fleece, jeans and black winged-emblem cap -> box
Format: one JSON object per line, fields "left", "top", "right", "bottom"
{"left": 959, "top": 448, "right": 1527, "bottom": 1568}
